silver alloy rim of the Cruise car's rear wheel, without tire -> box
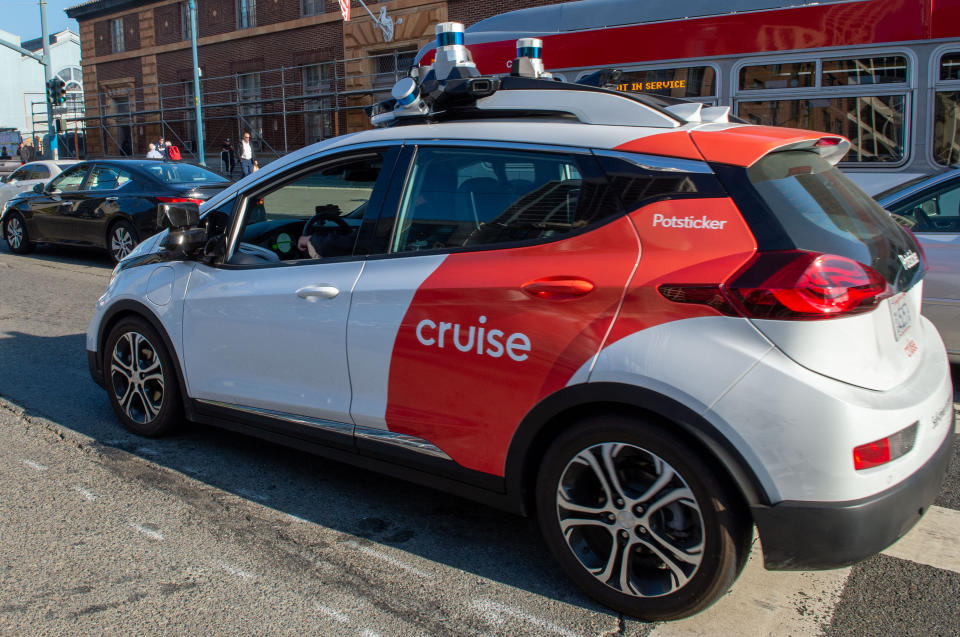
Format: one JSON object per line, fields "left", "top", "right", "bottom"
{"left": 556, "top": 442, "right": 706, "bottom": 597}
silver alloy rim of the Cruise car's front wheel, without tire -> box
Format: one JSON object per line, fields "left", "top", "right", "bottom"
{"left": 110, "top": 332, "right": 164, "bottom": 424}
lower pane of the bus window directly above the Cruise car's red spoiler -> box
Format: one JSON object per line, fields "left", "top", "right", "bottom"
{"left": 737, "top": 95, "right": 907, "bottom": 163}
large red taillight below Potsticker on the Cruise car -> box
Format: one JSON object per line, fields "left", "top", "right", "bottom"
{"left": 659, "top": 250, "right": 892, "bottom": 320}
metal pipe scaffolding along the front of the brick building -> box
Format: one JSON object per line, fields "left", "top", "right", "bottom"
{"left": 67, "top": 50, "right": 414, "bottom": 166}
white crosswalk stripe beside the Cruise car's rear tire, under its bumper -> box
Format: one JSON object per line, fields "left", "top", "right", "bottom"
{"left": 650, "top": 542, "right": 850, "bottom": 637}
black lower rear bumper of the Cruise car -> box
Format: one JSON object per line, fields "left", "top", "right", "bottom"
{"left": 751, "top": 410, "right": 955, "bottom": 570}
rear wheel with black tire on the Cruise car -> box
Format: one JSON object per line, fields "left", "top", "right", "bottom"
{"left": 536, "top": 414, "right": 753, "bottom": 621}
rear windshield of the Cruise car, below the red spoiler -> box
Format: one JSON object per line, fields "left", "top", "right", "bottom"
{"left": 747, "top": 151, "right": 923, "bottom": 291}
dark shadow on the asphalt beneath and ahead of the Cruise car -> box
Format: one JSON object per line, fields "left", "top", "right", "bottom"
{"left": 0, "top": 332, "right": 612, "bottom": 615}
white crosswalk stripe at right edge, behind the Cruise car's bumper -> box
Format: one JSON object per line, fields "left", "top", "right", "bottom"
{"left": 883, "top": 506, "right": 960, "bottom": 573}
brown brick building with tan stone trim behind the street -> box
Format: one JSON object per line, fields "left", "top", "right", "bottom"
{"left": 66, "top": 0, "right": 554, "bottom": 156}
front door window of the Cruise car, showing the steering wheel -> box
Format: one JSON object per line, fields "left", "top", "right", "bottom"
{"left": 240, "top": 154, "right": 383, "bottom": 261}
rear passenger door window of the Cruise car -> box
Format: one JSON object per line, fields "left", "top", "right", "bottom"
{"left": 391, "top": 147, "right": 615, "bottom": 252}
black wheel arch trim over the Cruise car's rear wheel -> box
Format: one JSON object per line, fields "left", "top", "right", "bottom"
{"left": 505, "top": 383, "right": 769, "bottom": 514}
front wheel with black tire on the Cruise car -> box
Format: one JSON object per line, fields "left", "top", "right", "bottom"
{"left": 103, "top": 317, "right": 183, "bottom": 438}
